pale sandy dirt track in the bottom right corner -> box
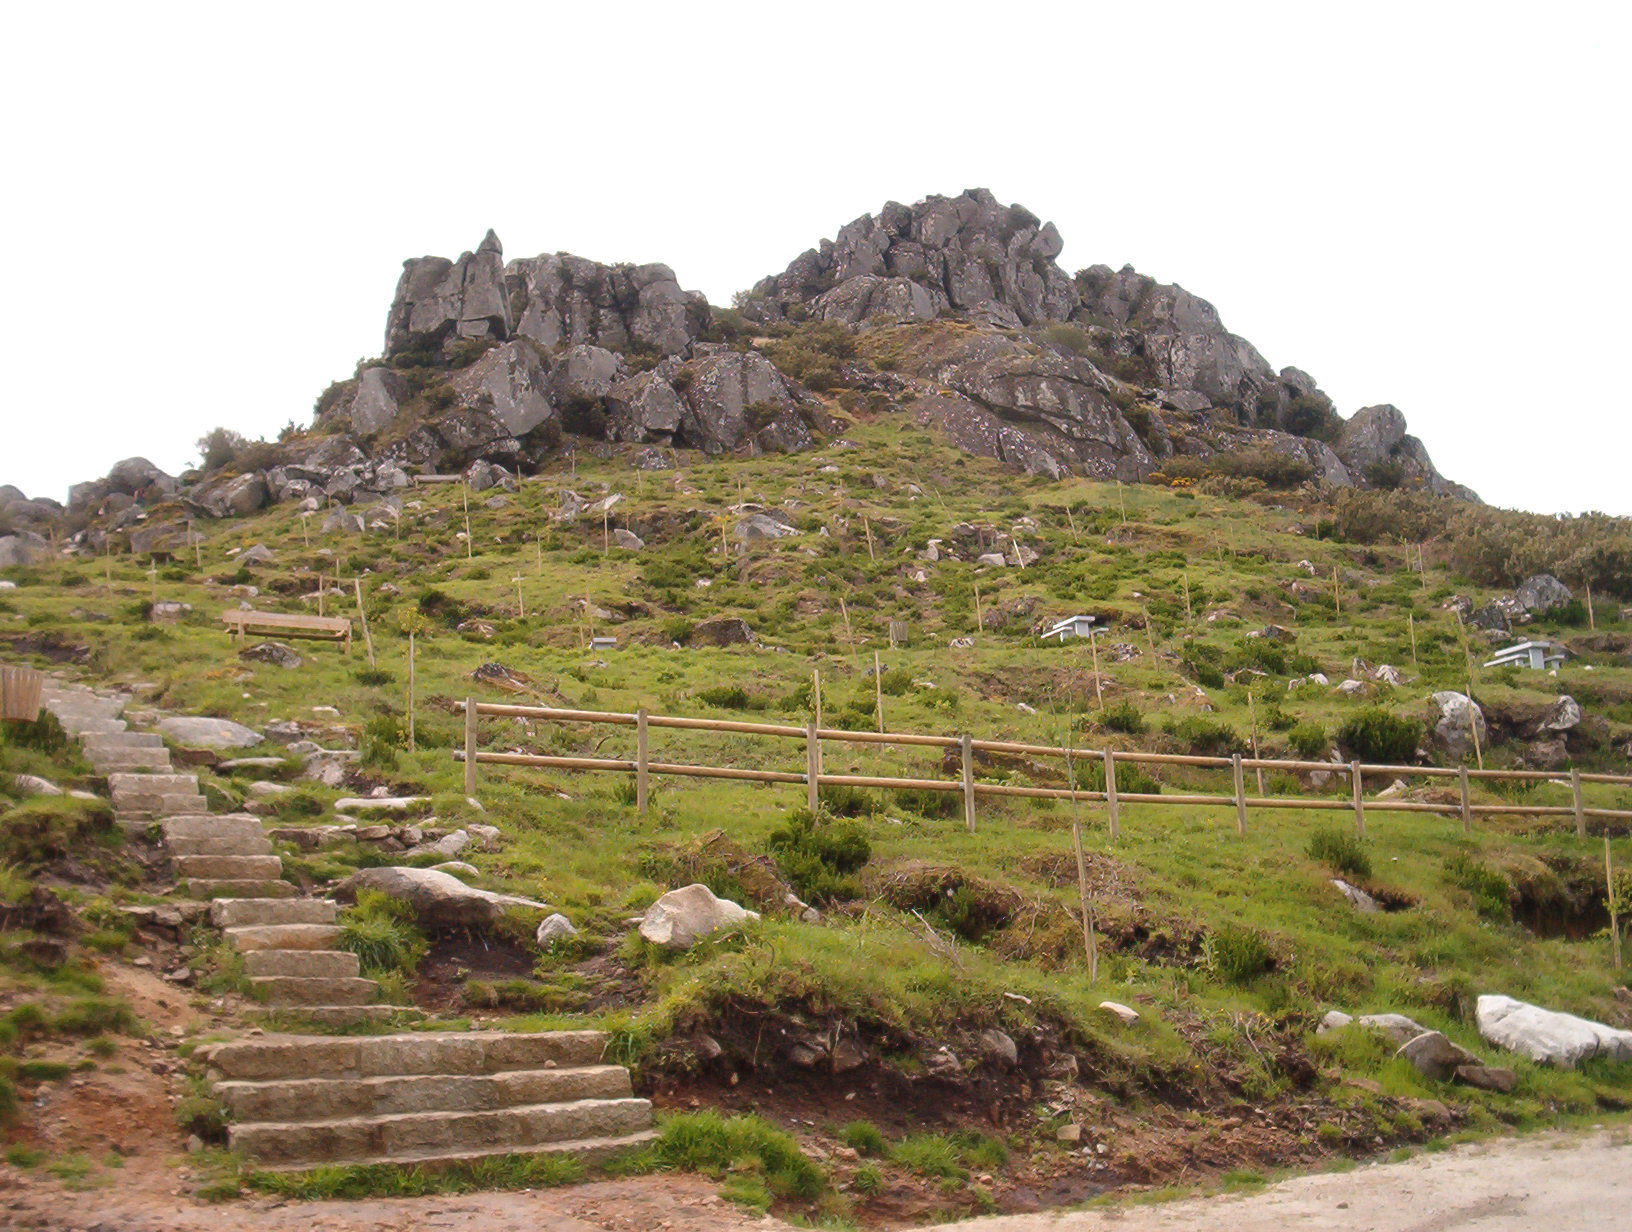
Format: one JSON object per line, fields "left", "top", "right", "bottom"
{"left": 930, "top": 1129, "right": 1632, "bottom": 1232}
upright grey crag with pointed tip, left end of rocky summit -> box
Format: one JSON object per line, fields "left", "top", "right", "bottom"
{"left": 385, "top": 232, "right": 511, "bottom": 354}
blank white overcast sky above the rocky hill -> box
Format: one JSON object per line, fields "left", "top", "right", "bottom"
{"left": 0, "top": 0, "right": 1632, "bottom": 514}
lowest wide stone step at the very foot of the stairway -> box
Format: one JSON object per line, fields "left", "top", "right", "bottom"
{"left": 230, "top": 1098, "right": 651, "bottom": 1167}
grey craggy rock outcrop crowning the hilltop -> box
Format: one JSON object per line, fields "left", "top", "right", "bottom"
{"left": 0, "top": 189, "right": 1477, "bottom": 560}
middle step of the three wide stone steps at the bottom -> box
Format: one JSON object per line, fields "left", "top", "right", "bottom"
{"left": 215, "top": 1066, "right": 633, "bottom": 1124}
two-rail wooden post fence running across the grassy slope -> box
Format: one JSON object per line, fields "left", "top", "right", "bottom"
{"left": 454, "top": 698, "right": 1632, "bottom": 839}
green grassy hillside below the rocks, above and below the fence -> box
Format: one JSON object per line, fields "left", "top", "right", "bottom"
{"left": 0, "top": 416, "right": 1632, "bottom": 1187}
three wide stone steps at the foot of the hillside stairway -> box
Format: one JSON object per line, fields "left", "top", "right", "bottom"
{"left": 201, "top": 1031, "right": 653, "bottom": 1170}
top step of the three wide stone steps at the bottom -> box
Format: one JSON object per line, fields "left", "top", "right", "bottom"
{"left": 206, "top": 1031, "right": 607, "bottom": 1082}
